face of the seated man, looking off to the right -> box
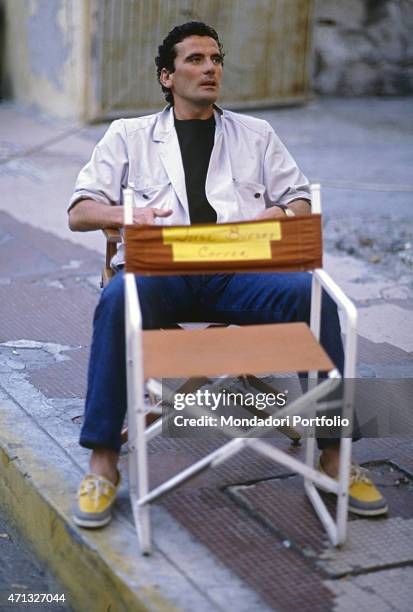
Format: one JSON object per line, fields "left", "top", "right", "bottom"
{"left": 161, "top": 36, "right": 222, "bottom": 106}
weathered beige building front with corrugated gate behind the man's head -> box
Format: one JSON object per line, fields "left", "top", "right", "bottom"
{"left": 0, "top": 0, "right": 314, "bottom": 121}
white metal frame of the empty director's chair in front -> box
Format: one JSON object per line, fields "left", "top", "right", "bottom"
{"left": 124, "top": 185, "right": 357, "bottom": 554}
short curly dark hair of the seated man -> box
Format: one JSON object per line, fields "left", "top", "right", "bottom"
{"left": 155, "top": 21, "right": 225, "bottom": 104}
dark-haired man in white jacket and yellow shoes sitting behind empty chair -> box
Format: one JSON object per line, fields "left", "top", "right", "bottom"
{"left": 69, "top": 22, "right": 387, "bottom": 527}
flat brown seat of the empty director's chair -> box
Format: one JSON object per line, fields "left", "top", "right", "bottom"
{"left": 143, "top": 323, "right": 334, "bottom": 378}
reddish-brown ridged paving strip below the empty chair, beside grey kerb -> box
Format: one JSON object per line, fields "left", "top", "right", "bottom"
{"left": 162, "top": 486, "right": 333, "bottom": 612}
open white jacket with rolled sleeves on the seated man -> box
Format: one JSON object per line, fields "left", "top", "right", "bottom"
{"left": 69, "top": 107, "right": 311, "bottom": 263}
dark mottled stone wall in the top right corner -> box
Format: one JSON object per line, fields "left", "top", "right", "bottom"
{"left": 313, "top": 0, "right": 413, "bottom": 96}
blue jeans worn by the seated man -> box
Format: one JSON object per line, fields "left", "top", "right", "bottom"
{"left": 80, "top": 272, "right": 344, "bottom": 450}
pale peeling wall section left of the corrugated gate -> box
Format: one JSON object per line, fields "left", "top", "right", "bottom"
{"left": 4, "top": 0, "right": 87, "bottom": 118}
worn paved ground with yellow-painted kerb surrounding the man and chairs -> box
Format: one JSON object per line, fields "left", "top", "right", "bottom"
{"left": 0, "top": 99, "right": 413, "bottom": 612}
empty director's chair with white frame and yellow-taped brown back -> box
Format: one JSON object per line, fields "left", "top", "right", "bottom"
{"left": 124, "top": 185, "right": 357, "bottom": 554}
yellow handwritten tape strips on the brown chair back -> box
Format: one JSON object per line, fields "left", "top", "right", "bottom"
{"left": 162, "top": 221, "right": 281, "bottom": 261}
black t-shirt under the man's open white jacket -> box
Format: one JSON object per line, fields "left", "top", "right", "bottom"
{"left": 175, "top": 115, "right": 217, "bottom": 224}
